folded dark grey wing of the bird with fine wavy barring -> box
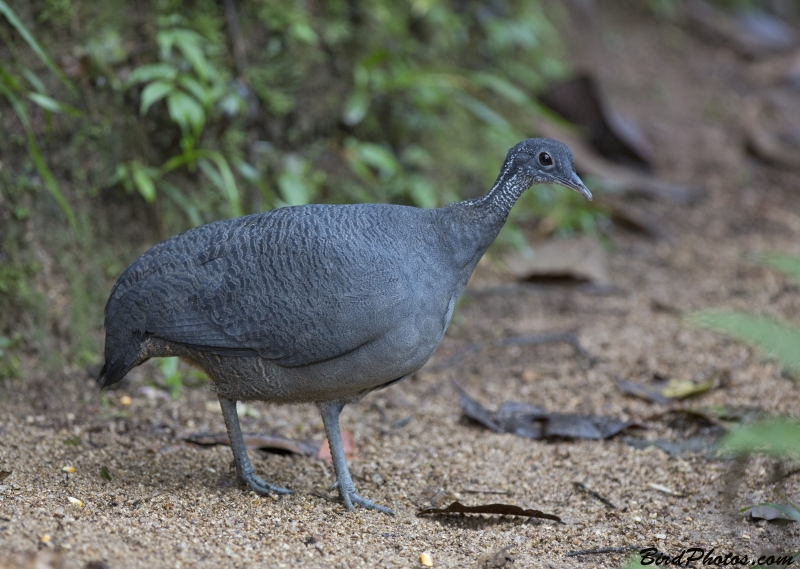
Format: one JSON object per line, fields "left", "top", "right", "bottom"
{"left": 106, "top": 207, "right": 407, "bottom": 366}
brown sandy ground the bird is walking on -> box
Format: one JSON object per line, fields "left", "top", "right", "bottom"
{"left": 0, "top": 3, "right": 800, "bottom": 568}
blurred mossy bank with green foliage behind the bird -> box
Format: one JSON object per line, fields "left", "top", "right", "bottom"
{"left": 0, "top": 0, "right": 600, "bottom": 376}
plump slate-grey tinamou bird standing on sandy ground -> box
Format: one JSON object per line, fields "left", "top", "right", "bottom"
{"left": 97, "top": 138, "right": 592, "bottom": 514}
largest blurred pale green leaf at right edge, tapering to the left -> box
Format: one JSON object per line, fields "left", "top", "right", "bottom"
{"left": 690, "top": 310, "right": 800, "bottom": 378}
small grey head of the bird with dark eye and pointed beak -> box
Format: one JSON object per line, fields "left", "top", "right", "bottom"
{"left": 503, "top": 138, "right": 592, "bottom": 199}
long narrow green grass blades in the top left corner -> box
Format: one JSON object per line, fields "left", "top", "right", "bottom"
{"left": 0, "top": 0, "right": 80, "bottom": 235}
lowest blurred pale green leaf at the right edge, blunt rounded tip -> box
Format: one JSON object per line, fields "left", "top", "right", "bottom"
{"left": 719, "top": 419, "right": 800, "bottom": 457}
